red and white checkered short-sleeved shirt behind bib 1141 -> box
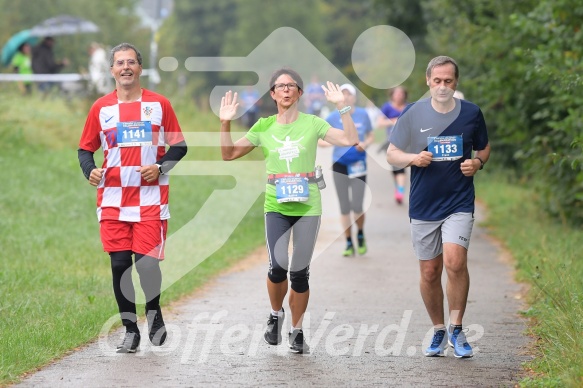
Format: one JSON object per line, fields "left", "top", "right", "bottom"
{"left": 79, "top": 89, "right": 184, "bottom": 222}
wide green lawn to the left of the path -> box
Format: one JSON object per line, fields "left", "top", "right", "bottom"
{"left": 0, "top": 92, "right": 264, "bottom": 386}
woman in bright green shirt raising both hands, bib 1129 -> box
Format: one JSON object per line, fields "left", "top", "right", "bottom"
{"left": 220, "top": 68, "right": 358, "bottom": 353}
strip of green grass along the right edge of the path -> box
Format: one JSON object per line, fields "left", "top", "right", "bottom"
{"left": 476, "top": 170, "right": 583, "bottom": 387}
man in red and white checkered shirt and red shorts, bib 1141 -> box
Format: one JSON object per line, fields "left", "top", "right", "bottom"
{"left": 78, "top": 43, "right": 187, "bottom": 353}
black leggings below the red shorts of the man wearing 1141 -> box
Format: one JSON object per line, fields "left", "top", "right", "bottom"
{"left": 109, "top": 251, "right": 162, "bottom": 331}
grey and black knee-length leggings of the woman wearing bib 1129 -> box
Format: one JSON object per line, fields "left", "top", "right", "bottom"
{"left": 265, "top": 212, "right": 320, "bottom": 293}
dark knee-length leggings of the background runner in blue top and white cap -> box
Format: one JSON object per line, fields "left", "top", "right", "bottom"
{"left": 332, "top": 163, "right": 366, "bottom": 215}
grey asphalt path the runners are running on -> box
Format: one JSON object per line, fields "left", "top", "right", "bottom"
{"left": 19, "top": 145, "right": 529, "bottom": 387}
